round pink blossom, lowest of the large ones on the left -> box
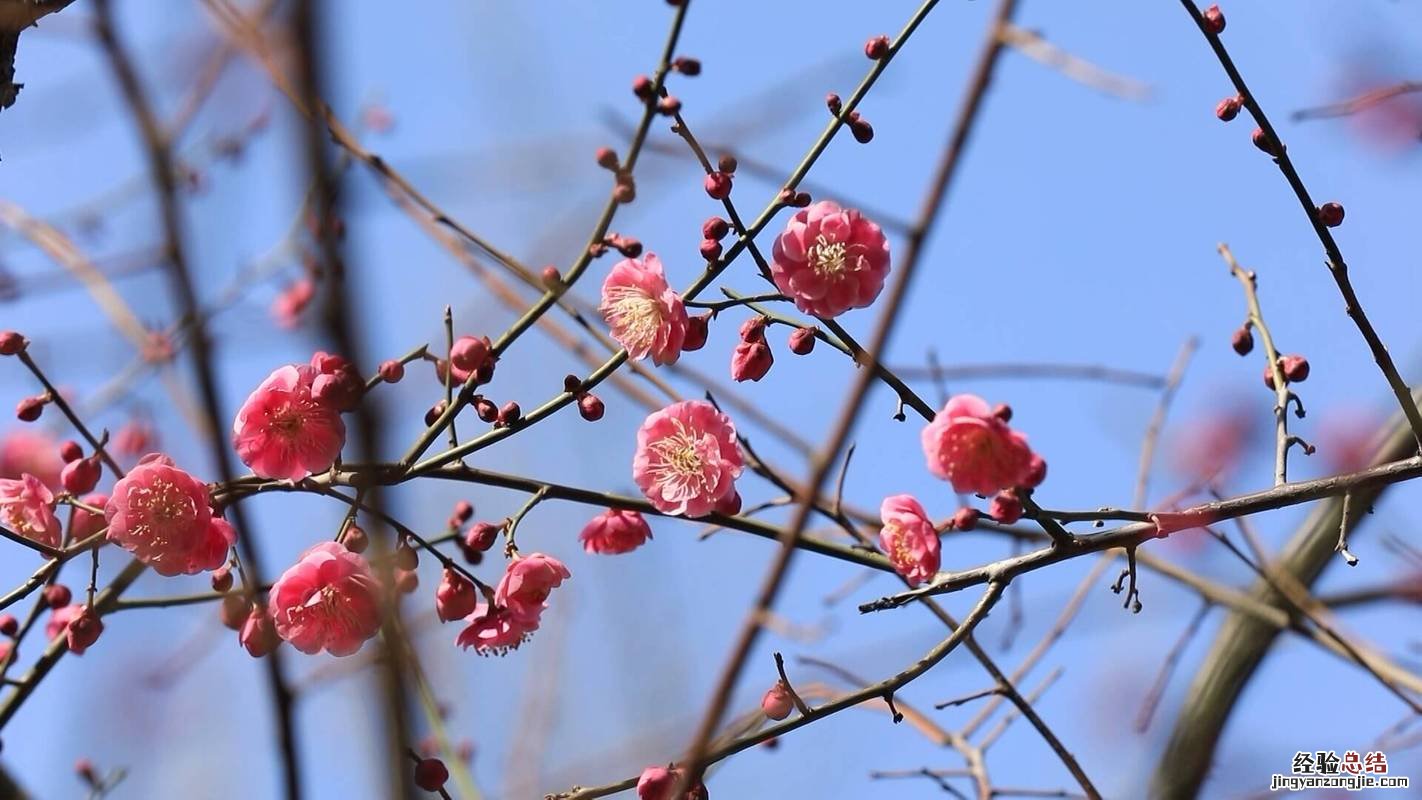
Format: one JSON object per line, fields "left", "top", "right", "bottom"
{"left": 267, "top": 541, "right": 380, "bottom": 655}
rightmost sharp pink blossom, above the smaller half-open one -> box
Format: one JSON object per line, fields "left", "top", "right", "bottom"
{"left": 921, "top": 395, "right": 1047, "bottom": 496}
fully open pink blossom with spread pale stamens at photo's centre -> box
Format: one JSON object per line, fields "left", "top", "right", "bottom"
{"left": 631, "top": 401, "right": 744, "bottom": 517}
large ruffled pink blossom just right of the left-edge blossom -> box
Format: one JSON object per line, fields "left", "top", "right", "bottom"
{"left": 104, "top": 453, "right": 237, "bottom": 575}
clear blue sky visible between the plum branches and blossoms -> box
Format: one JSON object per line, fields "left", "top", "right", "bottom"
{"left": 0, "top": 0, "right": 1422, "bottom": 799}
